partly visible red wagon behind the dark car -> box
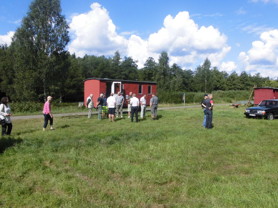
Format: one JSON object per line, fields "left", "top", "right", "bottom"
{"left": 254, "top": 87, "right": 278, "bottom": 105}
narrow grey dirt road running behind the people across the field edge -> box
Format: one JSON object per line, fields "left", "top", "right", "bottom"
{"left": 12, "top": 104, "right": 229, "bottom": 120}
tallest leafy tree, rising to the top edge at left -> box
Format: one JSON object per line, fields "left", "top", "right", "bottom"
{"left": 12, "top": 0, "right": 69, "bottom": 100}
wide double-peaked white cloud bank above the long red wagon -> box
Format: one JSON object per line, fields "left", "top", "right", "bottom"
{"left": 69, "top": 3, "right": 231, "bottom": 68}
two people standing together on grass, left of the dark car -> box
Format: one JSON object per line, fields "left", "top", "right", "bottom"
{"left": 201, "top": 94, "right": 213, "bottom": 129}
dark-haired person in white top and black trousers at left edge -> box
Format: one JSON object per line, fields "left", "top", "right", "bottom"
{"left": 0, "top": 97, "right": 13, "bottom": 136}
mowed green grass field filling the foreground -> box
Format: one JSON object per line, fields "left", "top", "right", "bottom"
{"left": 0, "top": 106, "right": 278, "bottom": 208}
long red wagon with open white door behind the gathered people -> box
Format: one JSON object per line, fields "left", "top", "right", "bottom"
{"left": 84, "top": 78, "right": 156, "bottom": 105}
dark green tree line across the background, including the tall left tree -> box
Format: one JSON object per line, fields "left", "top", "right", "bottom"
{"left": 0, "top": 0, "right": 278, "bottom": 102}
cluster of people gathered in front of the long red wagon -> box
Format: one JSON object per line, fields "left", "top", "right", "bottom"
{"left": 86, "top": 92, "right": 158, "bottom": 122}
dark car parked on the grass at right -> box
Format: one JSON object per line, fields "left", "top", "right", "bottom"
{"left": 244, "top": 99, "right": 278, "bottom": 120}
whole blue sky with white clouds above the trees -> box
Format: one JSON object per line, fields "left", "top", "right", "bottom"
{"left": 0, "top": 0, "right": 278, "bottom": 79}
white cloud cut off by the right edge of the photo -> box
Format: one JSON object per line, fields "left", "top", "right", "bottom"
{"left": 239, "top": 30, "right": 278, "bottom": 77}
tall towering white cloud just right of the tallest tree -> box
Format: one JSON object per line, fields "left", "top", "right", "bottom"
{"left": 69, "top": 3, "right": 127, "bottom": 56}
